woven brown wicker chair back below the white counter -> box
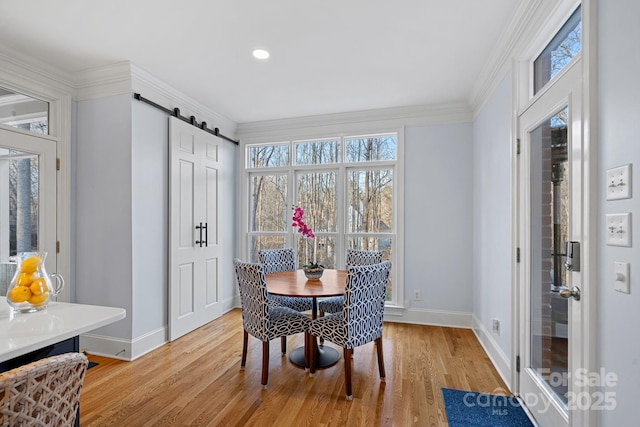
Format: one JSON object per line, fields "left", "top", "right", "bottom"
{"left": 0, "top": 353, "right": 89, "bottom": 427}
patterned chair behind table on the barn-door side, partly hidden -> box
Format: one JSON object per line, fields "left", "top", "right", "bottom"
{"left": 258, "top": 248, "right": 313, "bottom": 355}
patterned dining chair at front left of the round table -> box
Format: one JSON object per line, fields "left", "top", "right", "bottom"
{"left": 233, "top": 258, "right": 311, "bottom": 389}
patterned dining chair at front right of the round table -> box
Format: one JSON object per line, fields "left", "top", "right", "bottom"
{"left": 309, "top": 261, "right": 391, "bottom": 400}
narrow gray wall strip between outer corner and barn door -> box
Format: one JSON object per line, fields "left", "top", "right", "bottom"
{"left": 130, "top": 100, "right": 169, "bottom": 337}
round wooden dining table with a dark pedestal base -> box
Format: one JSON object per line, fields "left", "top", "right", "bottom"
{"left": 265, "top": 269, "right": 347, "bottom": 369}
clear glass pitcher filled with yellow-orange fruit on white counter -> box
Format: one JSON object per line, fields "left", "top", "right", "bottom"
{"left": 7, "top": 252, "right": 64, "bottom": 313}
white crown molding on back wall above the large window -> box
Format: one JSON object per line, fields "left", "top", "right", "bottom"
{"left": 237, "top": 104, "right": 473, "bottom": 142}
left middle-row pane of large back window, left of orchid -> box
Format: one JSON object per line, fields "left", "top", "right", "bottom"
{"left": 249, "top": 174, "right": 289, "bottom": 231}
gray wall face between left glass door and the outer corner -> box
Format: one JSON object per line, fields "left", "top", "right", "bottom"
{"left": 72, "top": 95, "right": 133, "bottom": 338}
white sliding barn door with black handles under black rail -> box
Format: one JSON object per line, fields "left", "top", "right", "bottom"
{"left": 169, "top": 117, "right": 222, "bottom": 341}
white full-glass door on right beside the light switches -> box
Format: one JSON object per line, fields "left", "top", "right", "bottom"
{"left": 518, "top": 60, "right": 595, "bottom": 427}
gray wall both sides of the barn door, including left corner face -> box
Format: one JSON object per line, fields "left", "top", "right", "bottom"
{"left": 72, "top": 94, "right": 238, "bottom": 357}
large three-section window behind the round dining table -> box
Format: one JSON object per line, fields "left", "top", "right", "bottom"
{"left": 245, "top": 133, "right": 402, "bottom": 303}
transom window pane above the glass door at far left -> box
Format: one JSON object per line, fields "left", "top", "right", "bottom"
{"left": 0, "top": 87, "right": 49, "bottom": 135}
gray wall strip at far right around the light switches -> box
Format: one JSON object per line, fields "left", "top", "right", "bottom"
{"left": 595, "top": 0, "right": 640, "bottom": 426}
